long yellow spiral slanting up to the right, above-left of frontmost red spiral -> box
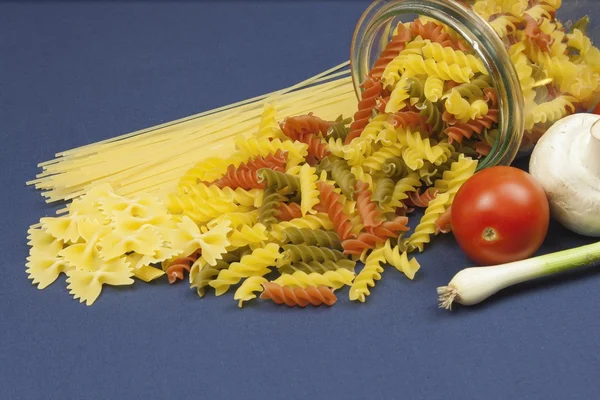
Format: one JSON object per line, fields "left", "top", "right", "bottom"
{"left": 209, "top": 243, "right": 279, "bottom": 296}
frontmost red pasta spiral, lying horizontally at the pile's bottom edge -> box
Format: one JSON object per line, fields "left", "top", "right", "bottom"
{"left": 260, "top": 282, "right": 337, "bottom": 307}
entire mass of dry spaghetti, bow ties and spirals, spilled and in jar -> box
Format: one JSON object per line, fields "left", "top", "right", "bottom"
{"left": 27, "top": 0, "right": 600, "bottom": 307}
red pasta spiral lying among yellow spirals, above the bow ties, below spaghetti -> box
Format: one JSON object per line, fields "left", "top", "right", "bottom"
{"left": 215, "top": 150, "right": 287, "bottom": 190}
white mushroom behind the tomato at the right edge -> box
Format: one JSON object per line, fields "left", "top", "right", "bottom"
{"left": 529, "top": 113, "right": 600, "bottom": 236}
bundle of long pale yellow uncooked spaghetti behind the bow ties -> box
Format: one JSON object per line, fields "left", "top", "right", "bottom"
{"left": 28, "top": 63, "right": 356, "bottom": 212}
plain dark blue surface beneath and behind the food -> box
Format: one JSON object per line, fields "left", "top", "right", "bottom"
{"left": 0, "top": 0, "right": 600, "bottom": 399}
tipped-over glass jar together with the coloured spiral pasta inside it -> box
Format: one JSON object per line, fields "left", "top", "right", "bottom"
{"left": 347, "top": 0, "right": 600, "bottom": 170}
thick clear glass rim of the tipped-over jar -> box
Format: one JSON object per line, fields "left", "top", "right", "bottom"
{"left": 350, "top": 0, "right": 600, "bottom": 169}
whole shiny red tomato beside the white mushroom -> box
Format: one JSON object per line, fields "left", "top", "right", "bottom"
{"left": 452, "top": 167, "right": 550, "bottom": 265}
